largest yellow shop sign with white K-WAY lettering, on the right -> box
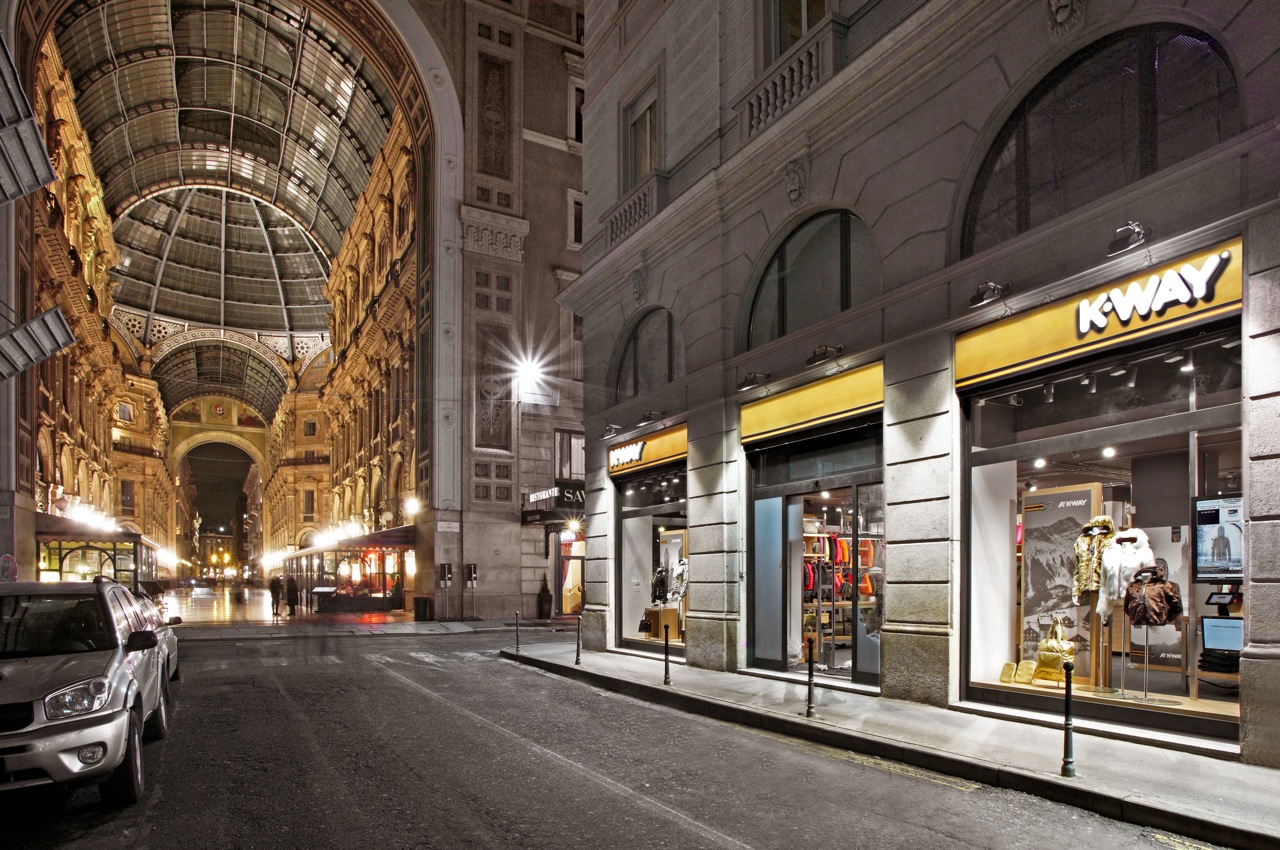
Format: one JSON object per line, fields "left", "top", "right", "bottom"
{"left": 955, "top": 238, "right": 1243, "bottom": 387}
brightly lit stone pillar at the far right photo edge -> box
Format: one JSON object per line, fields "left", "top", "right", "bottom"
{"left": 1240, "top": 213, "right": 1280, "bottom": 767}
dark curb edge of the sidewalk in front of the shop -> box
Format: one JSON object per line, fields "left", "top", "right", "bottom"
{"left": 499, "top": 649, "right": 1277, "bottom": 850}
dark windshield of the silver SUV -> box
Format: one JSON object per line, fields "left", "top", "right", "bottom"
{"left": 0, "top": 593, "right": 115, "bottom": 658}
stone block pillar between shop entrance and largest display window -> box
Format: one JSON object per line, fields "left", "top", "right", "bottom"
{"left": 881, "top": 333, "right": 960, "bottom": 705}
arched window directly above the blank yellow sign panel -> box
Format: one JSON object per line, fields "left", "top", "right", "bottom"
{"left": 748, "top": 210, "right": 881, "bottom": 348}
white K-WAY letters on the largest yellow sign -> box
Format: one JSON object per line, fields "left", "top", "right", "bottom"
{"left": 1076, "top": 251, "right": 1231, "bottom": 338}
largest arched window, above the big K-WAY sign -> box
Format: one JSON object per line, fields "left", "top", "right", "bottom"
{"left": 961, "top": 24, "right": 1242, "bottom": 256}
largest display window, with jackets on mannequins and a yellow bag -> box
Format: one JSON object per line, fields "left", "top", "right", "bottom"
{"left": 964, "top": 321, "right": 1244, "bottom": 737}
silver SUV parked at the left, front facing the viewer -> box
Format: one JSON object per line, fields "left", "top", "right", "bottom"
{"left": 0, "top": 579, "right": 169, "bottom": 805}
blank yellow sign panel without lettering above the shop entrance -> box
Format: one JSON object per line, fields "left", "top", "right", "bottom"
{"left": 741, "top": 361, "right": 884, "bottom": 443}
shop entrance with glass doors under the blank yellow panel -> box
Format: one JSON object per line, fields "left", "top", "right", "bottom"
{"left": 748, "top": 419, "right": 884, "bottom": 685}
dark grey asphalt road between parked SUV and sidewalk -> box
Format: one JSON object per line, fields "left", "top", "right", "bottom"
{"left": 0, "top": 632, "right": 1228, "bottom": 850}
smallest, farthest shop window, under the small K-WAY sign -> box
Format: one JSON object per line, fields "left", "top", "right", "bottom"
{"left": 616, "top": 465, "right": 689, "bottom": 648}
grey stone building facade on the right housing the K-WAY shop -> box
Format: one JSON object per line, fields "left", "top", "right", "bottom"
{"left": 562, "top": 0, "right": 1280, "bottom": 766}
